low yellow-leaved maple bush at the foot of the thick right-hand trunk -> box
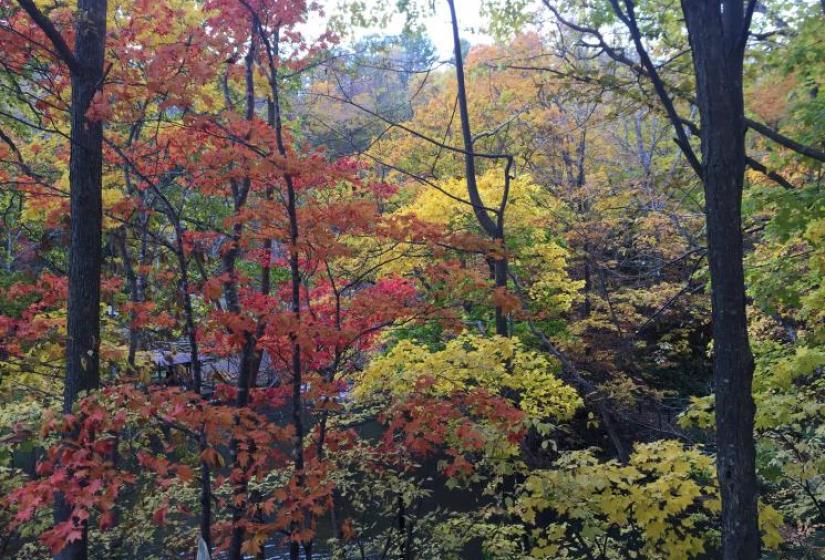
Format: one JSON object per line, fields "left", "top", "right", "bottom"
{"left": 513, "top": 440, "right": 782, "bottom": 559}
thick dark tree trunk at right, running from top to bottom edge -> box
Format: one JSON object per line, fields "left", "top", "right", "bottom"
{"left": 682, "top": 0, "right": 760, "bottom": 560}
